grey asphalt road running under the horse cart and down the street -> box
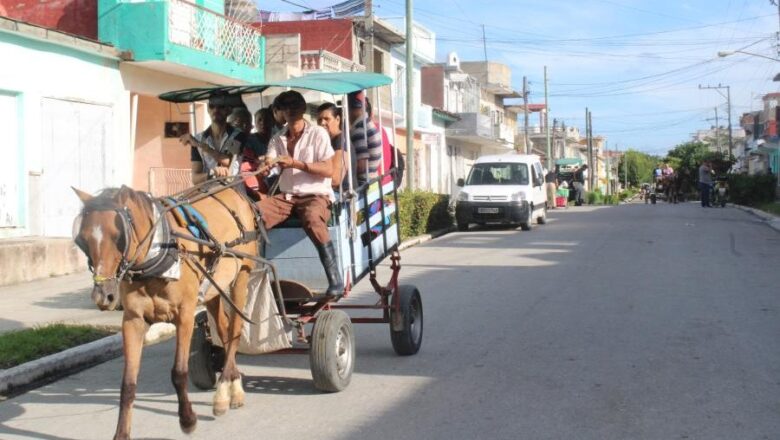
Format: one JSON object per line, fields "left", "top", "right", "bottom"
{"left": 0, "top": 204, "right": 780, "bottom": 440}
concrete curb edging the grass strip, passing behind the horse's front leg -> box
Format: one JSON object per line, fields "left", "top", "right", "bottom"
{"left": 0, "top": 323, "right": 176, "bottom": 400}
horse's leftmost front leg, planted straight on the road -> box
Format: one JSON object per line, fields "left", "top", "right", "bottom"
{"left": 114, "top": 310, "right": 146, "bottom": 440}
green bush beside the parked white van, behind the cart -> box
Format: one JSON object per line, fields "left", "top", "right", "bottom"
{"left": 398, "top": 191, "right": 453, "bottom": 239}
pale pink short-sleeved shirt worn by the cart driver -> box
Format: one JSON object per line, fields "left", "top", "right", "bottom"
{"left": 267, "top": 121, "right": 335, "bottom": 201}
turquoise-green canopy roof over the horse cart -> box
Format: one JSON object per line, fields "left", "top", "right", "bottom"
{"left": 160, "top": 72, "right": 393, "bottom": 103}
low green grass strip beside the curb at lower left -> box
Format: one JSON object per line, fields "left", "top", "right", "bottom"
{"left": 0, "top": 324, "right": 115, "bottom": 369}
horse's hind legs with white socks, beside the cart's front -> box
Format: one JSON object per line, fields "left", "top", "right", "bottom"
{"left": 214, "top": 266, "right": 249, "bottom": 414}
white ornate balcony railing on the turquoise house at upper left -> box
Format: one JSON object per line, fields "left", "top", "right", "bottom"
{"left": 168, "top": 0, "right": 262, "bottom": 67}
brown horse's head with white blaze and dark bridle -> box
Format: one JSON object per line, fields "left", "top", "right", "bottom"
{"left": 73, "top": 187, "right": 132, "bottom": 310}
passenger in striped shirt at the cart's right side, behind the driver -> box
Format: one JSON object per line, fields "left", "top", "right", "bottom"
{"left": 347, "top": 92, "right": 382, "bottom": 186}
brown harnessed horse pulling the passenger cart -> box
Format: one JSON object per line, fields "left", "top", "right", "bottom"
{"left": 74, "top": 186, "right": 258, "bottom": 439}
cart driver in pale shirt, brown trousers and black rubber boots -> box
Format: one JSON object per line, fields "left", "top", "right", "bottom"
{"left": 258, "top": 91, "right": 344, "bottom": 297}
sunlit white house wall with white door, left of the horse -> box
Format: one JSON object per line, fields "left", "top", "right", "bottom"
{"left": 0, "top": 32, "right": 133, "bottom": 238}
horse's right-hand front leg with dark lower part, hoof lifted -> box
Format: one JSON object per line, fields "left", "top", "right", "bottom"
{"left": 171, "top": 304, "right": 198, "bottom": 434}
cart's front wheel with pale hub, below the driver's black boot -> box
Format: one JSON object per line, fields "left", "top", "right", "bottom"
{"left": 309, "top": 310, "right": 355, "bottom": 392}
